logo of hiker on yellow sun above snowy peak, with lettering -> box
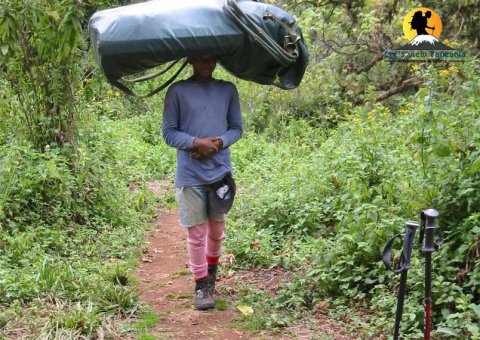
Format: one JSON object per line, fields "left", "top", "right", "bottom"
{"left": 383, "top": 7, "right": 466, "bottom": 62}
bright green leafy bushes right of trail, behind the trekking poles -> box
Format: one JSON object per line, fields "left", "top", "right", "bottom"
{"left": 229, "top": 61, "right": 480, "bottom": 337}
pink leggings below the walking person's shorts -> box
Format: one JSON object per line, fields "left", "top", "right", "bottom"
{"left": 187, "top": 218, "right": 225, "bottom": 280}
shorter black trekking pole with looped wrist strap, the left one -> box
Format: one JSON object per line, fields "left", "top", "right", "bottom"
{"left": 382, "top": 221, "right": 419, "bottom": 340}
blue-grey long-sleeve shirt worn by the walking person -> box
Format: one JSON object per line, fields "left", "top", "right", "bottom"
{"left": 163, "top": 80, "right": 243, "bottom": 187}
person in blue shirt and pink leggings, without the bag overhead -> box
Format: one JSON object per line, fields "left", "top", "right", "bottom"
{"left": 162, "top": 56, "right": 243, "bottom": 310}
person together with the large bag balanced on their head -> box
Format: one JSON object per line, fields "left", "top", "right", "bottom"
{"left": 89, "top": 0, "right": 308, "bottom": 309}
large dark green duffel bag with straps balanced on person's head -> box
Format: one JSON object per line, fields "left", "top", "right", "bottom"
{"left": 89, "top": 0, "right": 308, "bottom": 92}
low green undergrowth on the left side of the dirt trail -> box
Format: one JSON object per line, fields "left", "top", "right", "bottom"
{"left": 0, "top": 108, "right": 173, "bottom": 339}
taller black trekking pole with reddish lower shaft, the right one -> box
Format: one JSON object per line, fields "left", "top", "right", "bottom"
{"left": 420, "top": 209, "right": 439, "bottom": 340}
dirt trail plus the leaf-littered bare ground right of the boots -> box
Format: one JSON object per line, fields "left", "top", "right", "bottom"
{"left": 137, "top": 182, "right": 351, "bottom": 340}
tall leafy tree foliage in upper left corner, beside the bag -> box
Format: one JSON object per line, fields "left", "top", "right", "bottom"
{"left": 0, "top": 0, "right": 84, "bottom": 149}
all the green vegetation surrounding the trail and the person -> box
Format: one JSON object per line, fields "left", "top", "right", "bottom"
{"left": 0, "top": 0, "right": 480, "bottom": 339}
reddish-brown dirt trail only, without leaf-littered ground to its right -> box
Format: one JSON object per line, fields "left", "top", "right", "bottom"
{"left": 138, "top": 182, "right": 249, "bottom": 339}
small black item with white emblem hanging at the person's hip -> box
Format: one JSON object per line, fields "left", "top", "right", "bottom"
{"left": 208, "top": 172, "right": 237, "bottom": 214}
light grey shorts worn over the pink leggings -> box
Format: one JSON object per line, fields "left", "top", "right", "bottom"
{"left": 175, "top": 185, "right": 225, "bottom": 227}
